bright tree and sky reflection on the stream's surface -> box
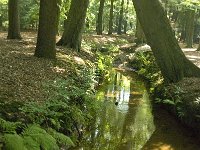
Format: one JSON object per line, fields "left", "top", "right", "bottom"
{"left": 76, "top": 71, "right": 155, "bottom": 150}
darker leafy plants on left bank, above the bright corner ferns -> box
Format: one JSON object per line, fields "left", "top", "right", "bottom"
{"left": 21, "top": 68, "right": 97, "bottom": 139}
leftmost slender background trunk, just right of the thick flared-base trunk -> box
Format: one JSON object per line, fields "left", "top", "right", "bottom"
{"left": 97, "top": 0, "right": 105, "bottom": 35}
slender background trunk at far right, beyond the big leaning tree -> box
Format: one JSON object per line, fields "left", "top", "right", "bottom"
{"left": 186, "top": 10, "right": 195, "bottom": 48}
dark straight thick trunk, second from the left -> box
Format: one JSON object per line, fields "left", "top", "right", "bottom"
{"left": 35, "top": 0, "right": 60, "bottom": 58}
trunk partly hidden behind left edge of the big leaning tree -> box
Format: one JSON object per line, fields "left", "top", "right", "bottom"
{"left": 135, "top": 19, "right": 145, "bottom": 45}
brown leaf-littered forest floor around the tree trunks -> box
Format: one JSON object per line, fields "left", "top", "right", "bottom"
{"left": 0, "top": 32, "right": 200, "bottom": 101}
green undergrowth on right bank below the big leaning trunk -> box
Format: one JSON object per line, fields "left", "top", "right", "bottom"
{"left": 128, "top": 47, "right": 200, "bottom": 125}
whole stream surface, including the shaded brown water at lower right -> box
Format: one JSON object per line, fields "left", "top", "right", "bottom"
{"left": 73, "top": 69, "right": 200, "bottom": 150}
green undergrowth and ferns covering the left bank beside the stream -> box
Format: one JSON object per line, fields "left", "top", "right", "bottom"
{"left": 0, "top": 58, "right": 98, "bottom": 150}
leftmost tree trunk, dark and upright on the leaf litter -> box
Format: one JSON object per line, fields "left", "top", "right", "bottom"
{"left": 7, "top": 0, "right": 21, "bottom": 39}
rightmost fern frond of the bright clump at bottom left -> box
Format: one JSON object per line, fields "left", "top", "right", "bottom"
{"left": 48, "top": 128, "right": 75, "bottom": 146}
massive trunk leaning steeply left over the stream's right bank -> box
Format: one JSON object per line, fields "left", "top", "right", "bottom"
{"left": 133, "top": 0, "right": 200, "bottom": 83}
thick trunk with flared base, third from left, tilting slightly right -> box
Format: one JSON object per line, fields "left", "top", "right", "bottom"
{"left": 57, "top": 0, "right": 89, "bottom": 51}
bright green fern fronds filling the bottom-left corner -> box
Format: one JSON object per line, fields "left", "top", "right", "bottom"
{"left": 0, "top": 119, "right": 74, "bottom": 150}
